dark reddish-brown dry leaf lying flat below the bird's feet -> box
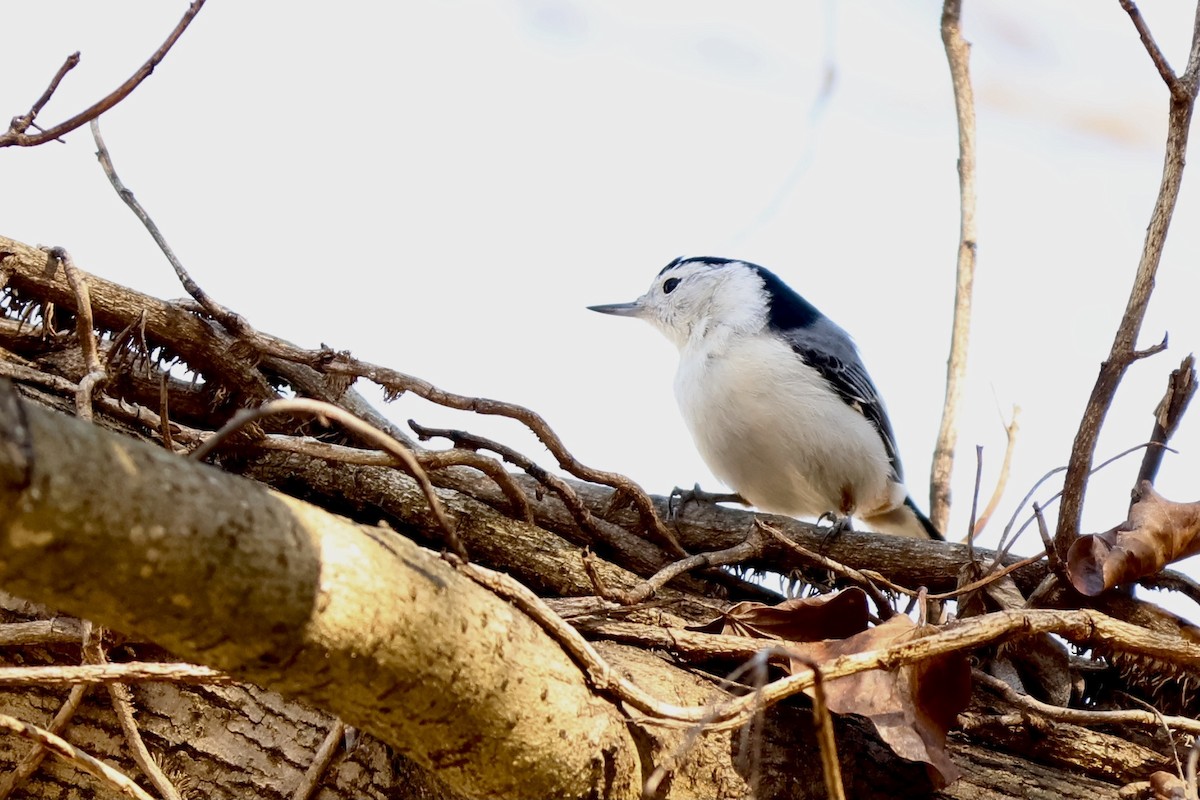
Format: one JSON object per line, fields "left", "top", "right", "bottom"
{"left": 694, "top": 587, "right": 868, "bottom": 642}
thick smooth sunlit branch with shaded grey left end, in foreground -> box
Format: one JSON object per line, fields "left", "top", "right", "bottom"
{"left": 0, "top": 387, "right": 638, "bottom": 798}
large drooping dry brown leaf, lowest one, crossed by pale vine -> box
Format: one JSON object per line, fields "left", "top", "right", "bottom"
{"left": 790, "top": 614, "right": 971, "bottom": 788}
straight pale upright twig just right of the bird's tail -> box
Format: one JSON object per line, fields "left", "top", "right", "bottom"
{"left": 929, "top": 0, "right": 978, "bottom": 530}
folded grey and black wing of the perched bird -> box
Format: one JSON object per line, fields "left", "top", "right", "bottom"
{"left": 787, "top": 323, "right": 904, "bottom": 482}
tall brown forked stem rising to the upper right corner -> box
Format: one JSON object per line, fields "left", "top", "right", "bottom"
{"left": 1055, "top": 5, "right": 1200, "bottom": 561}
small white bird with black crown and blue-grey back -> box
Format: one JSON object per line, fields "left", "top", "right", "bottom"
{"left": 588, "top": 255, "right": 943, "bottom": 540}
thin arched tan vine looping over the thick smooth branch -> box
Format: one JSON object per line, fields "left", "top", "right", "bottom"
{"left": 191, "top": 397, "right": 470, "bottom": 561}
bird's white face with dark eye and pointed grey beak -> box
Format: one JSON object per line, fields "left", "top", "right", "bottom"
{"left": 589, "top": 261, "right": 766, "bottom": 348}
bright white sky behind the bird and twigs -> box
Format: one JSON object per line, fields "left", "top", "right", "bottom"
{"left": 7, "top": 0, "right": 1200, "bottom": 615}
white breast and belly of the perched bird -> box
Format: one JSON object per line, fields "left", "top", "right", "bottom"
{"left": 676, "top": 331, "right": 902, "bottom": 517}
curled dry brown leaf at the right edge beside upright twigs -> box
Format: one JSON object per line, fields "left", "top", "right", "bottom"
{"left": 1067, "top": 481, "right": 1200, "bottom": 596}
